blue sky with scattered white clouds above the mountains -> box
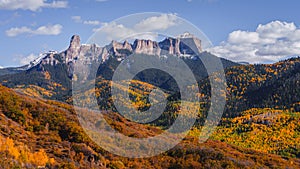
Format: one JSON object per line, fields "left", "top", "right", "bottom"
{"left": 0, "top": 0, "right": 300, "bottom": 67}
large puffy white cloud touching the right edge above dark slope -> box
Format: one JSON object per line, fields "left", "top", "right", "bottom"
{"left": 208, "top": 21, "right": 300, "bottom": 63}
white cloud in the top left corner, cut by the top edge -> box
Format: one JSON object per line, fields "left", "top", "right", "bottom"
{"left": 0, "top": 0, "right": 68, "bottom": 11}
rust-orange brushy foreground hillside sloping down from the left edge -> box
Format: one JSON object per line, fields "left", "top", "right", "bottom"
{"left": 0, "top": 86, "right": 300, "bottom": 168}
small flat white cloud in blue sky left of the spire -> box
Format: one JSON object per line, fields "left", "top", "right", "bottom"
{"left": 5, "top": 24, "right": 62, "bottom": 37}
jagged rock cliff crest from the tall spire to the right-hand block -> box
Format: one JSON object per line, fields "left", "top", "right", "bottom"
{"left": 57, "top": 34, "right": 202, "bottom": 64}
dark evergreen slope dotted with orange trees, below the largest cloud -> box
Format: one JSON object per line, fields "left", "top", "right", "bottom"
{"left": 192, "top": 57, "right": 300, "bottom": 117}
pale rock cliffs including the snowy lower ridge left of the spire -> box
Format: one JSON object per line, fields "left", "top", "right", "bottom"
{"left": 33, "top": 33, "right": 202, "bottom": 77}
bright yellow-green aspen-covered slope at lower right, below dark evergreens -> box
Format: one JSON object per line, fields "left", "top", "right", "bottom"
{"left": 212, "top": 108, "right": 300, "bottom": 158}
